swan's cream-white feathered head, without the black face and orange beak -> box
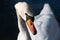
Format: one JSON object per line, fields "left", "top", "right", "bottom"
{"left": 15, "top": 2, "right": 33, "bottom": 21}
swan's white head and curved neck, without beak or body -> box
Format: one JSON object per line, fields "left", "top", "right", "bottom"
{"left": 15, "top": 2, "right": 33, "bottom": 40}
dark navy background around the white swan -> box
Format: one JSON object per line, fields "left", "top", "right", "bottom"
{"left": 0, "top": 0, "right": 60, "bottom": 40}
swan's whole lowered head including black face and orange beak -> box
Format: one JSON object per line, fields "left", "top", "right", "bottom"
{"left": 15, "top": 2, "right": 36, "bottom": 34}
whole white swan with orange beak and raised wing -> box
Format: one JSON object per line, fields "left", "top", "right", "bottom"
{"left": 15, "top": 2, "right": 59, "bottom": 40}
